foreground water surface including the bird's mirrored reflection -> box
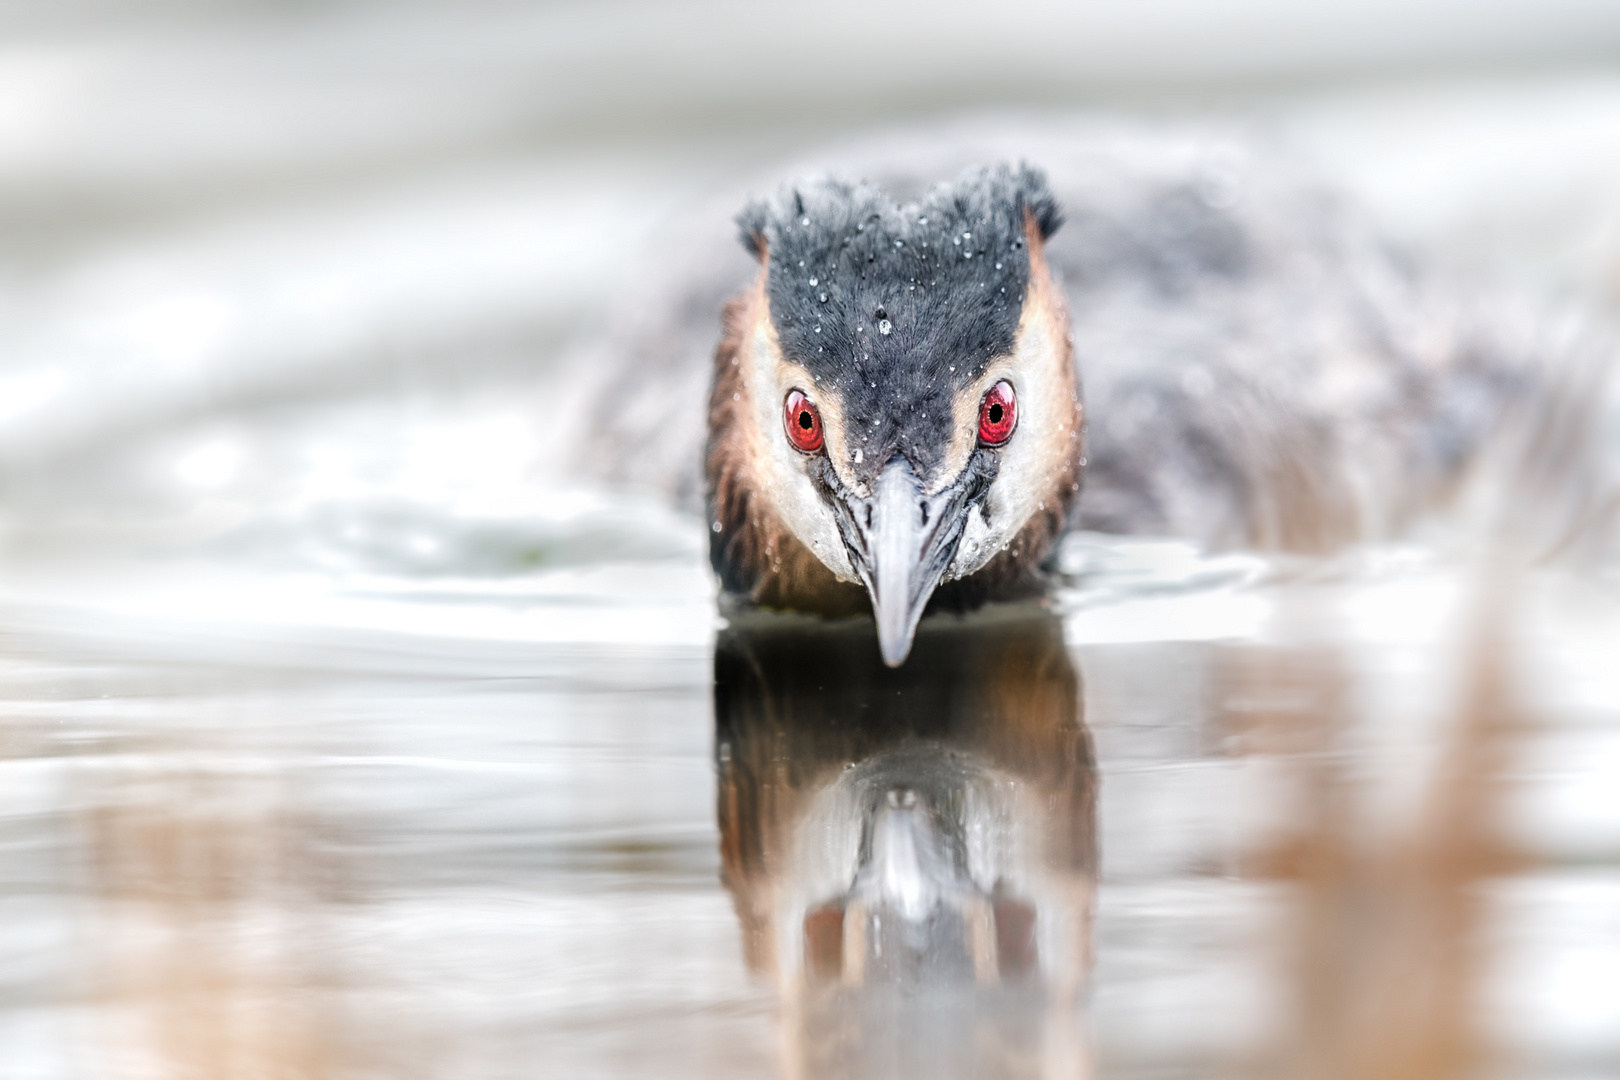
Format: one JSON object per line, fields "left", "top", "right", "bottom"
{"left": 0, "top": 527, "right": 1620, "bottom": 1077}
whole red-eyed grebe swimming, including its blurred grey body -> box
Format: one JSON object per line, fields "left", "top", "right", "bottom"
{"left": 576, "top": 130, "right": 1613, "bottom": 664}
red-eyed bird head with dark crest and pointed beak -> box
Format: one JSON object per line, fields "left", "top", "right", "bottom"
{"left": 708, "top": 165, "right": 1081, "bottom": 665}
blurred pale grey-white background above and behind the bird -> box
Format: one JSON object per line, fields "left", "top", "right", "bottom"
{"left": 0, "top": 0, "right": 1620, "bottom": 573}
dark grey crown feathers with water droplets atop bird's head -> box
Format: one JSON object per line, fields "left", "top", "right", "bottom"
{"left": 737, "top": 165, "right": 1061, "bottom": 485}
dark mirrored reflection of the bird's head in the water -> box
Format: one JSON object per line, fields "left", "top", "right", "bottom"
{"left": 714, "top": 606, "right": 1095, "bottom": 1077}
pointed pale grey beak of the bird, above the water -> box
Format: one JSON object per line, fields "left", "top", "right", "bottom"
{"left": 838, "top": 458, "right": 969, "bottom": 667}
